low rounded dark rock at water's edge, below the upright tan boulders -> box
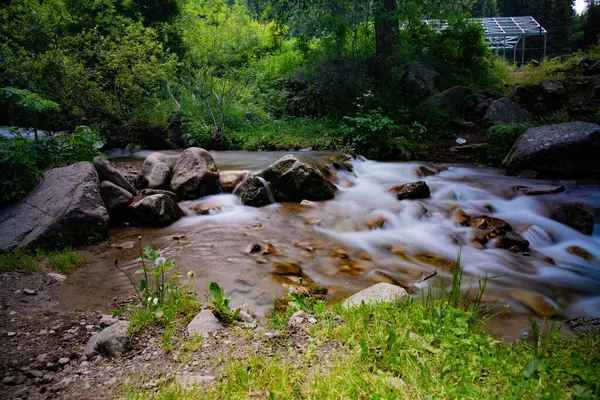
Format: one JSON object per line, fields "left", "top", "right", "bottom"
{"left": 131, "top": 194, "right": 183, "bottom": 226}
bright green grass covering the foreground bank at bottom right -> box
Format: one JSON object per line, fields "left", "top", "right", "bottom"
{"left": 126, "top": 259, "right": 600, "bottom": 399}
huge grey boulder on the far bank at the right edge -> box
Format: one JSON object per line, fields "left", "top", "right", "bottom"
{"left": 503, "top": 122, "right": 600, "bottom": 176}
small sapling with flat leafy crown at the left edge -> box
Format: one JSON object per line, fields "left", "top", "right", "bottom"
{"left": 0, "top": 87, "right": 60, "bottom": 141}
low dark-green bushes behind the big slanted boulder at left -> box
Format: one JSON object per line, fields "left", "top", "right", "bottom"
{"left": 0, "top": 126, "right": 100, "bottom": 207}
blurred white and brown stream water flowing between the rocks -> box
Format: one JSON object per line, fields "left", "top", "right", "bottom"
{"left": 57, "top": 152, "right": 600, "bottom": 336}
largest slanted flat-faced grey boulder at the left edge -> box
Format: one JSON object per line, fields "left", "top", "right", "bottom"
{"left": 0, "top": 162, "right": 108, "bottom": 251}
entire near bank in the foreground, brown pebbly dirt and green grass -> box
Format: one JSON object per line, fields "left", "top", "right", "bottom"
{"left": 0, "top": 258, "right": 600, "bottom": 400}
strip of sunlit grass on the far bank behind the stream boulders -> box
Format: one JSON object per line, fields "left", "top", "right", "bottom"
{"left": 223, "top": 118, "right": 341, "bottom": 151}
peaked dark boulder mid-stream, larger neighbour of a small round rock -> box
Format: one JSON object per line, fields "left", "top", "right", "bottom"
{"left": 258, "top": 155, "right": 337, "bottom": 203}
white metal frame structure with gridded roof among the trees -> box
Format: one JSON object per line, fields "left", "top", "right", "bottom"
{"left": 425, "top": 16, "right": 548, "bottom": 64}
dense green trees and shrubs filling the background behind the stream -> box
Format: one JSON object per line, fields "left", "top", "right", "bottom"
{"left": 0, "top": 0, "right": 600, "bottom": 205}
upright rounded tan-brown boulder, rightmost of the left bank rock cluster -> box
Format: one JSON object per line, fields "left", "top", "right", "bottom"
{"left": 171, "top": 147, "right": 219, "bottom": 199}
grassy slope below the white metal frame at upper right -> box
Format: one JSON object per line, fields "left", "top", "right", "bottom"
{"left": 508, "top": 46, "right": 600, "bottom": 86}
